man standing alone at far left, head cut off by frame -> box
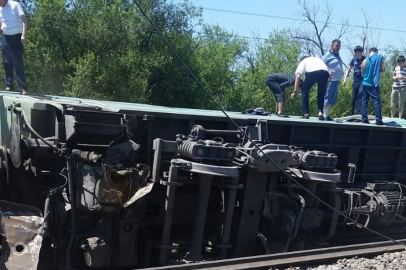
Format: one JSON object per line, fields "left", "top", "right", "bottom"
{"left": 0, "top": 0, "right": 28, "bottom": 95}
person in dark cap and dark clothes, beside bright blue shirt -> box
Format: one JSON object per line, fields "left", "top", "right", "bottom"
{"left": 343, "top": 46, "right": 365, "bottom": 115}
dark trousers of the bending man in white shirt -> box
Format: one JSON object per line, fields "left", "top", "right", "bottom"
{"left": 302, "top": 70, "right": 329, "bottom": 114}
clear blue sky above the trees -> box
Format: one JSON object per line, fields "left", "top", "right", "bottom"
{"left": 173, "top": 0, "right": 406, "bottom": 62}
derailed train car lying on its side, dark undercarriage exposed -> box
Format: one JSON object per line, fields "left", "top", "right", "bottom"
{"left": 0, "top": 92, "right": 406, "bottom": 269}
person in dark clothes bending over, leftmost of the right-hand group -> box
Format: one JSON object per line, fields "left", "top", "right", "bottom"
{"left": 265, "top": 73, "right": 301, "bottom": 117}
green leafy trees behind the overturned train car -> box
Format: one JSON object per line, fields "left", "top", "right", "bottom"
{"left": 8, "top": 0, "right": 399, "bottom": 117}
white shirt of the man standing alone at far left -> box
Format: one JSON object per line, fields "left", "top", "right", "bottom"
{"left": 0, "top": 0, "right": 25, "bottom": 35}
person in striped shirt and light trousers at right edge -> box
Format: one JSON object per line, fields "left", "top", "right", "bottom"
{"left": 390, "top": 55, "right": 406, "bottom": 118}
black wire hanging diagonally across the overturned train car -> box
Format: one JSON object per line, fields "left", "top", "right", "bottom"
{"left": 133, "top": 0, "right": 406, "bottom": 246}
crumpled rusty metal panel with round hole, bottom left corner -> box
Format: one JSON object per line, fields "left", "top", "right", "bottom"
{"left": 0, "top": 201, "right": 44, "bottom": 270}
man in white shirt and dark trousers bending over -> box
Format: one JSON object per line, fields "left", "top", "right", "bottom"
{"left": 291, "top": 57, "right": 331, "bottom": 120}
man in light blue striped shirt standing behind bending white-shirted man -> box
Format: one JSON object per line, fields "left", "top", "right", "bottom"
{"left": 323, "top": 39, "right": 344, "bottom": 121}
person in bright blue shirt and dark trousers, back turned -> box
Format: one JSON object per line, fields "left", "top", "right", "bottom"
{"left": 361, "top": 47, "right": 386, "bottom": 125}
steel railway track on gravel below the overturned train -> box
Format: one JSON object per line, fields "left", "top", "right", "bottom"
{"left": 147, "top": 239, "right": 406, "bottom": 270}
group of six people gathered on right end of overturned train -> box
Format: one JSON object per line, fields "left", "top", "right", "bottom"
{"left": 265, "top": 39, "right": 406, "bottom": 125}
